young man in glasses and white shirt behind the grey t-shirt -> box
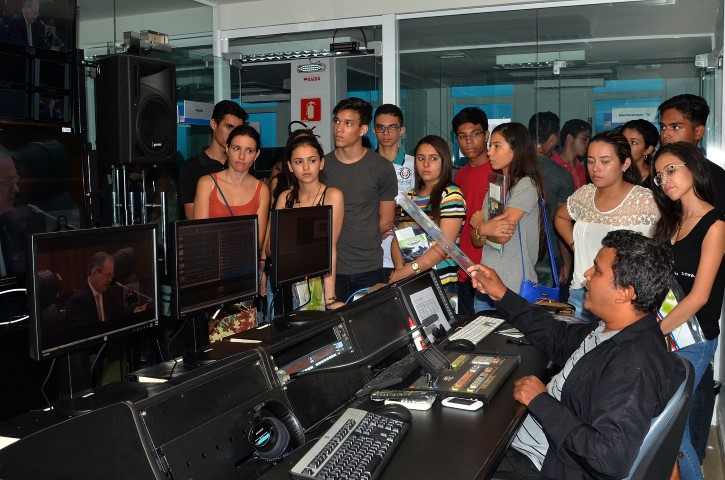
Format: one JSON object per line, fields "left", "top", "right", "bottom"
{"left": 373, "top": 103, "right": 415, "bottom": 278}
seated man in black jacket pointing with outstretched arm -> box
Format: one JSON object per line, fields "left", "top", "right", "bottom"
{"left": 469, "top": 230, "right": 685, "bottom": 479}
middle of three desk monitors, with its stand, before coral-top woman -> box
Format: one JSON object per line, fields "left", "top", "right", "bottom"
{"left": 169, "top": 215, "right": 259, "bottom": 365}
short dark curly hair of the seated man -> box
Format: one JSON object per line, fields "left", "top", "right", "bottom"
{"left": 602, "top": 230, "right": 674, "bottom": 313}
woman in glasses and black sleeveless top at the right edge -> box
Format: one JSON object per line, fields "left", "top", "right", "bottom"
{"left": 651, "top": 142, "right": 725, "bottom": 480}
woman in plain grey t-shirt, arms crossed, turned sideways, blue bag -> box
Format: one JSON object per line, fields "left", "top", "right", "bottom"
{"left": 471, "top": 123, "right": 546, "bottom": 311}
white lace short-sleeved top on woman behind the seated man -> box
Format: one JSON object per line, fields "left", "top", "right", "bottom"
{"left": 566, "top": 183, "right": 660, "bottom": 288}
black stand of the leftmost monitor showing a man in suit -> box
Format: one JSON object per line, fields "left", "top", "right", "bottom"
{"left": 53, "top": 349, "right": 148, "bottom": 417}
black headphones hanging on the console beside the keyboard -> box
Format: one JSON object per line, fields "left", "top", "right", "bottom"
{"left": 247, "top": 400, "right": 305, "bottom": 462}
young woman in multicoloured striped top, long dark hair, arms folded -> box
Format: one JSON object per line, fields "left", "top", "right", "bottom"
{"left": 390, "top": 135, "right": 466, "bottom": 293}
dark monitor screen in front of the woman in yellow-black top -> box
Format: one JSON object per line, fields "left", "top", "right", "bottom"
{"left": 270, "top": 205, "right": 332, "bottom": 288}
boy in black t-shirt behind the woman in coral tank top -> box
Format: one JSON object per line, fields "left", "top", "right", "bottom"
{"left": 179, "top": 100, "right": 249, "bottom": 219}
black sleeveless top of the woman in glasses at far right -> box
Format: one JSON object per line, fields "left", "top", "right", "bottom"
{"left": 672, "top": 210, "right": 725, "bottom": 340}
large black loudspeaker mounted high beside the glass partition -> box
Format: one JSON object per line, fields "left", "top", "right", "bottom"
{"left": 95, "top": 55, "right": 176, "bottom": 165}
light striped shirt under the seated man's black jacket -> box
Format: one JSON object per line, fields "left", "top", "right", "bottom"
{"left": 511, "top": 321, "right": 619, "bottom": 470}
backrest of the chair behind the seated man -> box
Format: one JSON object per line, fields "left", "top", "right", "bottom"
{"left": 626, "top": 357, "right": 695, "bottom": 480}
